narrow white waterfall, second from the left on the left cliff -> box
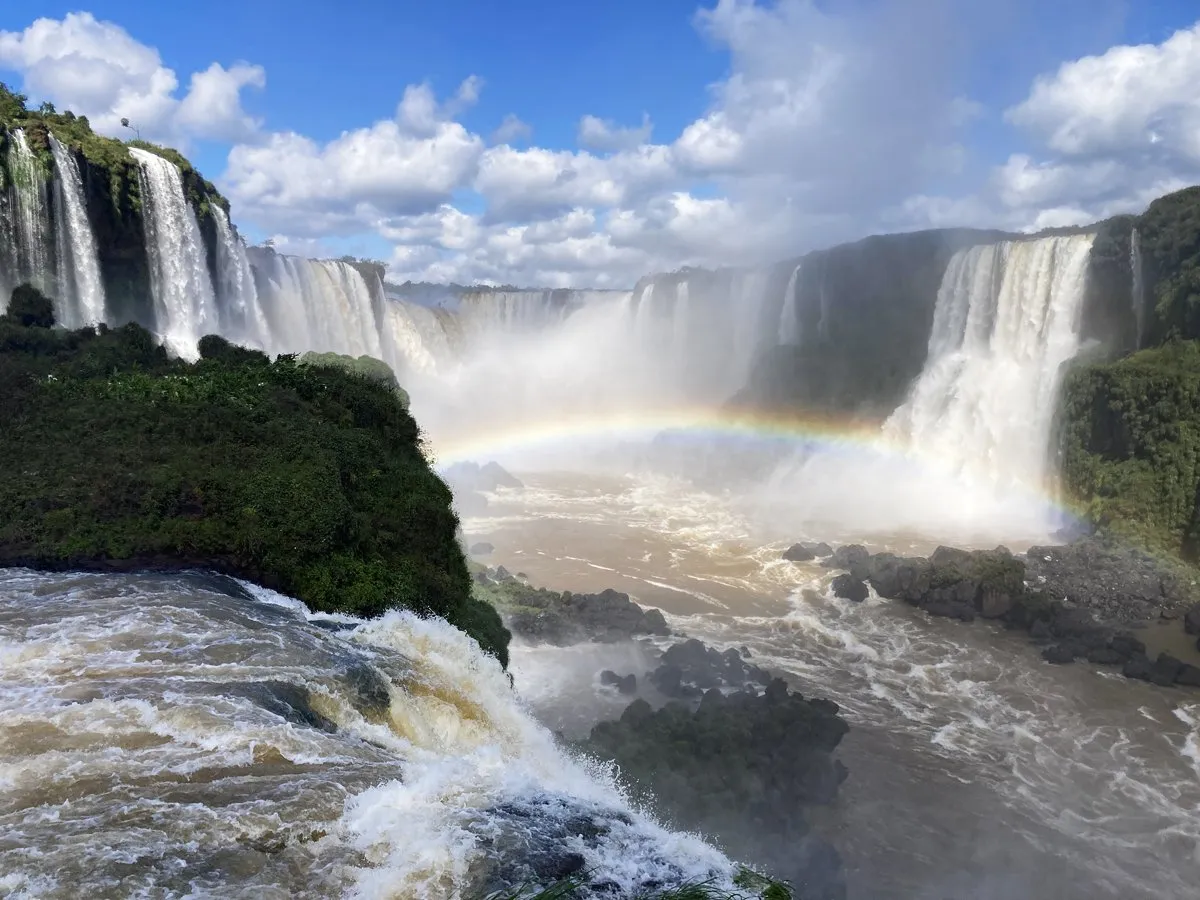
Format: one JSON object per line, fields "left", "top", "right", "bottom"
{"left": 49, "top": 134, "right": 104, "bottom": 328}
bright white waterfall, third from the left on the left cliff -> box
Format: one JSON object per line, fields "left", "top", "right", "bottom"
{"left": 130, "top": 148, "right": 220, "bottom": 359}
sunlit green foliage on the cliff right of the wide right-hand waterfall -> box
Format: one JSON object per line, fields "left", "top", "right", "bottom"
{"left": 1062, "top": 341, "right": 1200, "bottom": 558}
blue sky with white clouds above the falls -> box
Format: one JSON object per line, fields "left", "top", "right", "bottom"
{"left": 0, "top": 0, "right": 1200, "bottom": 287}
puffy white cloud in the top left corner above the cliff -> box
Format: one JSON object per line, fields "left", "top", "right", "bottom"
{"left": 0, "top": 12, "right": 266, "bottom": 143}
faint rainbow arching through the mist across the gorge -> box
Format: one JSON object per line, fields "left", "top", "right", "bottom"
{"left": 420, "top": 407, "right": 1082, "bottom": 517}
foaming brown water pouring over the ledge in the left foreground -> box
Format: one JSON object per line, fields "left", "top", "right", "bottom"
{"left": 0, "top": 570, "right": 732, "bottom": 900}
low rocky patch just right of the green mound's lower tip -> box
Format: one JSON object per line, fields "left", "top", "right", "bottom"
{"left": 475, "top": 566, "right": 671, "bottom": 647}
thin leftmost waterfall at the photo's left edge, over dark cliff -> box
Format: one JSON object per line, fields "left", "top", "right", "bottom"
{"left": 0, "top": 128, "right": 54, "bottom": 300}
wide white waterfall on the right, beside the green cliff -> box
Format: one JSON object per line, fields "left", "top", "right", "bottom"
{"left": 884, "top": 234, "right": 1093, "bottom": 485}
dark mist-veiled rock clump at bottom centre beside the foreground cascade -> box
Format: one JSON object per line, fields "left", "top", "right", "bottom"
{"left": 584, "top": 681, "right": 848, "bottom": 900}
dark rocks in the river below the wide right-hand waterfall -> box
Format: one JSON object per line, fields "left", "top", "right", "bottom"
{"left": 806, "top": 539, "right": 1200, "bottom": 686}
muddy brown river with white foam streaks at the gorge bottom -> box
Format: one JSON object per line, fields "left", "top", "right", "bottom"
{"left": 464, "top": 474, "right": 1200, "bottom": 900}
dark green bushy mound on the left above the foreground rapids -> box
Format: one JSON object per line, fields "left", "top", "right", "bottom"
{"left": 0, "top": 287, "right": 509, "bottom": 664}
